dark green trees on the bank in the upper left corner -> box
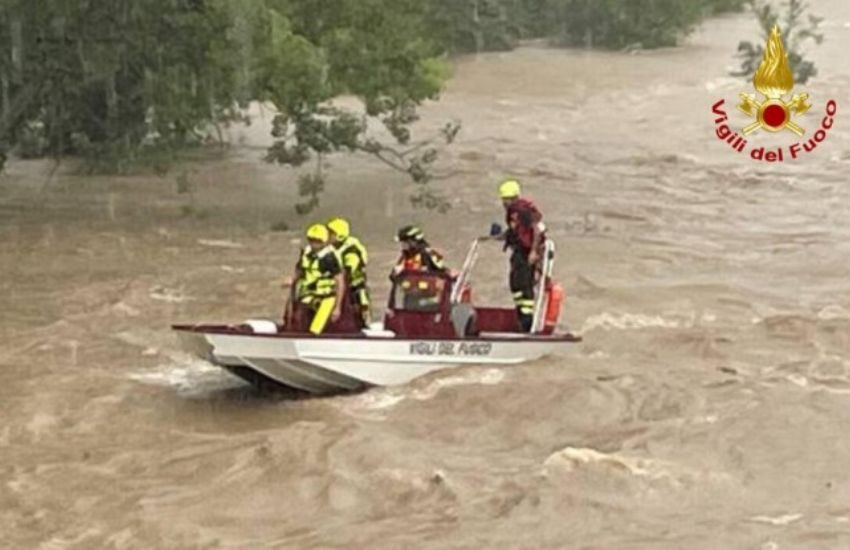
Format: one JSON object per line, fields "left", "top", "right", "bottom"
{"left": 0, "top": 0, "right": 248, "bottom": 170}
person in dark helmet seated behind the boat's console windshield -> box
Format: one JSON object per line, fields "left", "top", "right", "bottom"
{"left": 390, "top": 225, "right": 449, "bottom": 311}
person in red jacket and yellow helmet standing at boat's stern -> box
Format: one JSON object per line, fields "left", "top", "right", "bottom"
{"left": 496, "top": 179, "right": 548, "bottom": 332}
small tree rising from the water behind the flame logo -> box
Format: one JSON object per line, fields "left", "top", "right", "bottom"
{"left": 732, "top": 0, "right": 823, "bottom": 84}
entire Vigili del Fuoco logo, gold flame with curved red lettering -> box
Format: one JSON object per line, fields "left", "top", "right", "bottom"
{"left": 711, "top": 26, "right": 838, "bottom": 162}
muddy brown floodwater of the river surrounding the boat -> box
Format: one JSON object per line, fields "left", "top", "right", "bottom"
{"left": 0, "top": 7, "right": 850, "bottom": 550}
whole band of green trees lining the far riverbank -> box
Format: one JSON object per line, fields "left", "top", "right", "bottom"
{"left": 0, "top": 0, "right": 741, "bottom": 209}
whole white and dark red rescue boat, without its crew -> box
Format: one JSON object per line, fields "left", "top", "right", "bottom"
{"left": 172, "top": 239, "right": 581, "bottom": 394}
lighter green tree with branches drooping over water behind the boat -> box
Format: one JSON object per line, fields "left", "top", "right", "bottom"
{"left": 256, "top": 0, "right": 459, "bottom": 212}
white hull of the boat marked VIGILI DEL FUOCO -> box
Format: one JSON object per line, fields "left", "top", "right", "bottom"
{"left": 178, "top": 330, "right": 575, "bottom": 394}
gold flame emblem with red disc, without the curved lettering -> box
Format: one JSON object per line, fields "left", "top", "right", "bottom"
{"left": 738, "top": 25, "right": 812, "bottom": 136}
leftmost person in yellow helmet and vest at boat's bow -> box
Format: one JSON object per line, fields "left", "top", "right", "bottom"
{"left": 295, "top": 224, "right": 345, "bottom": 334}
